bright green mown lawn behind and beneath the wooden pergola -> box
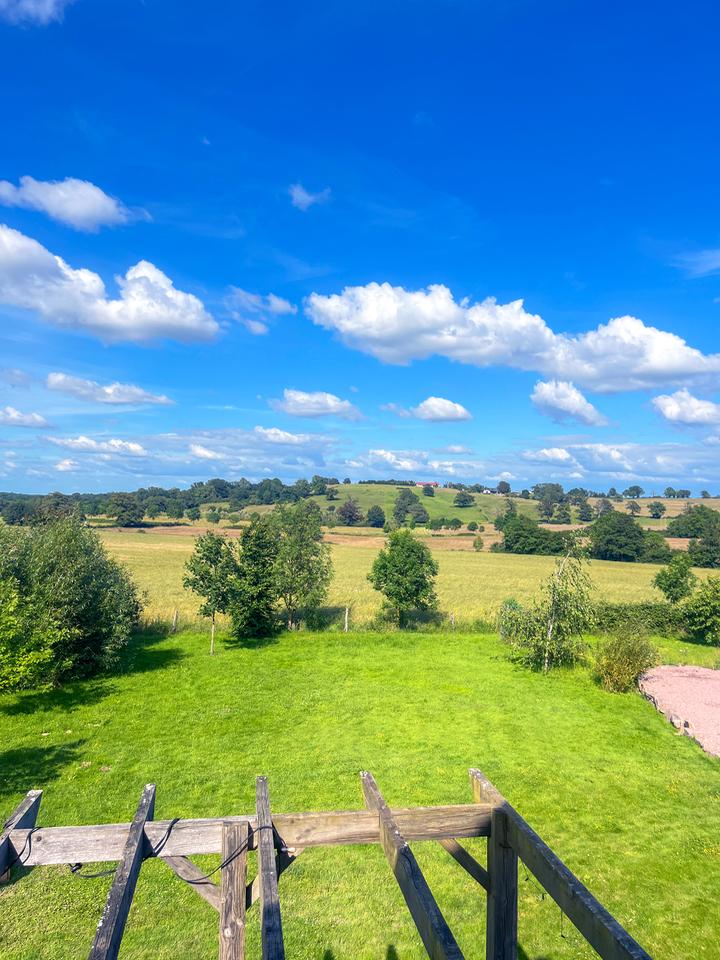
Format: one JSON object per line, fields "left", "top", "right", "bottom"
{"left": 0, "top": 632, "right": 720, "bottom": 960}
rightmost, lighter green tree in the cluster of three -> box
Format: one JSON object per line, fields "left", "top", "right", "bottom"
{"left": 273, "top": 503, "right": 332, "bottom": 630}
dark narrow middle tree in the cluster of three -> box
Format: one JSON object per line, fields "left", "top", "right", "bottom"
{"left": 228, "top": 513, "right": 278, "bottom": 641}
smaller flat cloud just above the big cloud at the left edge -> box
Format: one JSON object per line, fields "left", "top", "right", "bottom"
{"left": 0, "top": 177, "right": 132, "bottom": 233}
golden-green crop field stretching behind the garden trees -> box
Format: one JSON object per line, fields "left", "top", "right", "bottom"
{"left": 101, "top": 530, "right": 716, "bottom": 625}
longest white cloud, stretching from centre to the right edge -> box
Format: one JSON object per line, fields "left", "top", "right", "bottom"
{"left": 306, "top": 283, "right": 720, "bottom": 392}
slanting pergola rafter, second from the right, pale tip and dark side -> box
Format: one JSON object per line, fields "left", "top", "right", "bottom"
{"left": 360, "top": 772, "right": 462, "bottom": 960}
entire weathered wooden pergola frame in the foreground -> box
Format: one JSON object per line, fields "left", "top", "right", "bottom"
{"left": 0, "top": 770, "right": 651, "bottom": 960}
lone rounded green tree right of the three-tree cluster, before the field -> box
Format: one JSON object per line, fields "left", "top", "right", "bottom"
{"left": 368, "top": 530, "right": 438, "bottom": 626}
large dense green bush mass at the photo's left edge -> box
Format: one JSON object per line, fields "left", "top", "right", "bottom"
{"left": 0, "top": 517, "right": 142, "bottom": 689}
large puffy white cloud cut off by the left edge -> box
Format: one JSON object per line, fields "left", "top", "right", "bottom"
{"left": 0, "top": 224, "right": 219, "bottom": 342}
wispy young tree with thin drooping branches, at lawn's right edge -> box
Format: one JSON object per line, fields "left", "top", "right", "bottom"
{"left": 500, "top": 547, "right": 593, "bottom": 673}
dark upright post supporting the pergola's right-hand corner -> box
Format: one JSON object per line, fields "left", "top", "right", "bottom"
{"left": 485, "top": 806, "right": 518, "bottom": 960}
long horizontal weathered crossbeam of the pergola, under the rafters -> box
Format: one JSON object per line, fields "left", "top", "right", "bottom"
{"left": 10, "top": 803, "right": 491, "bottom": 866}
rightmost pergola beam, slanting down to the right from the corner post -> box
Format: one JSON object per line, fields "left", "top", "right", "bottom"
{"left": 470, "top": 770, "right": 651, "bottom": 960}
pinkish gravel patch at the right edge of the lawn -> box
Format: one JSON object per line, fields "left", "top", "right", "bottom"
{"left": 640, "top": 667, "right": 720, "bottom": 757}
